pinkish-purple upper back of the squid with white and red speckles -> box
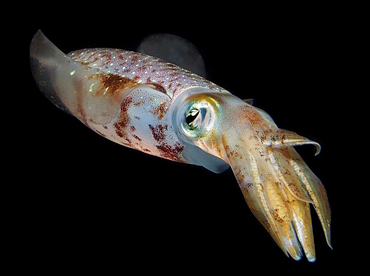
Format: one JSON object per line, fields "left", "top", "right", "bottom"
{"left": 68, "top": 49, "right": 226, "bottom": 98}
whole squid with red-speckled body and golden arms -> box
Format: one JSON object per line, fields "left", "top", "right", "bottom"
{"left": 30, "top": 31, "right": 331, "bottom": 262}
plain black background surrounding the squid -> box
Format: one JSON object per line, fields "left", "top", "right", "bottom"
{"left": 4, "top": 2, "right": 360, "bottom": 275}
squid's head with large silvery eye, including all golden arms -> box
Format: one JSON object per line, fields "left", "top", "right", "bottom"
{"left": 174, "top": 90, "right": 330, "bottom": 261}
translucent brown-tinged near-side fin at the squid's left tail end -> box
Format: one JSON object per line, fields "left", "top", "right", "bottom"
{"left": 30, "top": 30, "right": 137, "bottom": 125}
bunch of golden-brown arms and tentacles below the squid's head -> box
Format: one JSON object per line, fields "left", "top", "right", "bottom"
{"left": 222, "top": 113, "right": 330, "bottom": 262}
